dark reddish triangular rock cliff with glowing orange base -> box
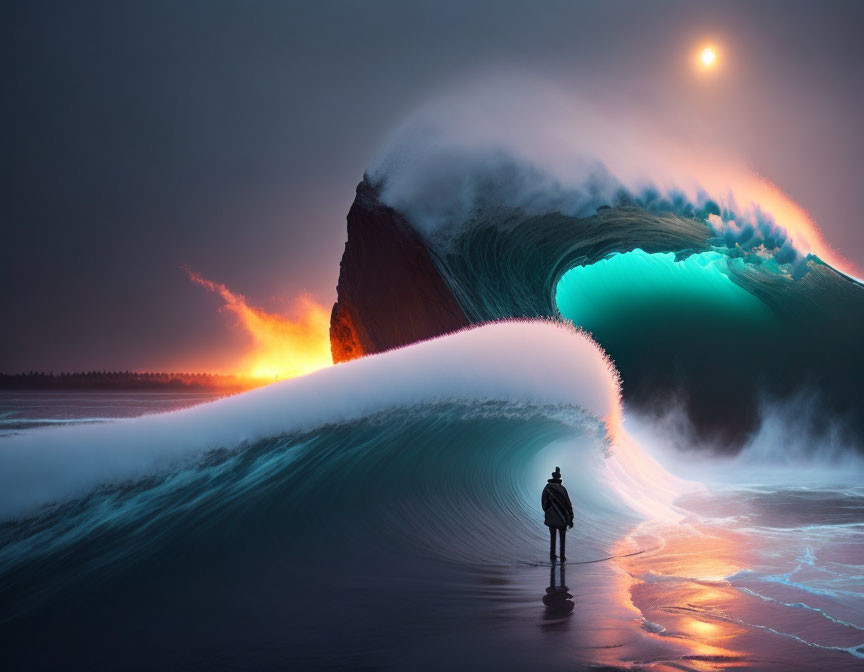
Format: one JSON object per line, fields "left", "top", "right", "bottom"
{"left": 330, "top": 178, "right": 468, "bottom": 362}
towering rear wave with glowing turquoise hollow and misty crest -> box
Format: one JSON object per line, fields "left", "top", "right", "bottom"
{"left": 331, "top": 94, "right": 864, "bottom": 450}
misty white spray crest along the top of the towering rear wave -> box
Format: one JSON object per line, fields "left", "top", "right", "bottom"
{"left": 369, "top": 77, "right": 848, "bottom": 277}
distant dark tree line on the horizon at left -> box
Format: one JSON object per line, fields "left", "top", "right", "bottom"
{"left": 0, "top": 371, "right": 256, "bottom": 390}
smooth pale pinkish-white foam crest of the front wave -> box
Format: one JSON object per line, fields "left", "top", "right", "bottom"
{"left": 0, "top": 321, "right": 620, "bottom": 519}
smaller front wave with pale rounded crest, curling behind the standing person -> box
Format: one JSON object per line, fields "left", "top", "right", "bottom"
{"left": 0, "top": 322, "right": 690, "bottom": 669}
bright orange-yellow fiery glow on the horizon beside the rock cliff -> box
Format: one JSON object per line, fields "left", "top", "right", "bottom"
{"left": 185, "top": 269, "right": 333, "bottom": 380}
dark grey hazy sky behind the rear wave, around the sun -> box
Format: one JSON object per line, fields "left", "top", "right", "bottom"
{"left": 0, "top": 0, "right": 864, "bottom": 370}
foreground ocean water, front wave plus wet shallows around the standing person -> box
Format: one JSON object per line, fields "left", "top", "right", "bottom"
{"left": 0, "top": 322, "right": 864, "bottom": 671}
